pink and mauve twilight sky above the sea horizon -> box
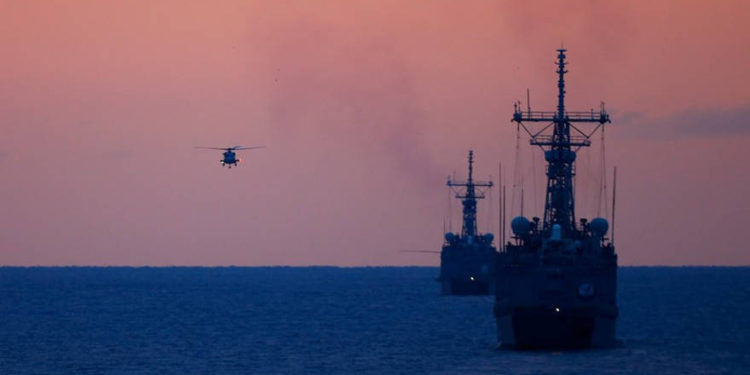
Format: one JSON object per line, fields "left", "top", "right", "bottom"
{"left": 0, "top": 0, "right": 750, "bottom": 266}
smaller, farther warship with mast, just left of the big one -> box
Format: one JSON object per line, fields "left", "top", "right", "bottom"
{"left": 438, "top": 151, "right": 497, "bottom": 295}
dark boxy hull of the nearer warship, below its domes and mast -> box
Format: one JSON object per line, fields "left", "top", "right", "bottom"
{"left": 494, "top": 248, "right": 619, "bottom": 349}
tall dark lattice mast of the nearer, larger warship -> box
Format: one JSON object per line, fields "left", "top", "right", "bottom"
{"left": 512, "top": 49, "right": 610, "bottom": 234}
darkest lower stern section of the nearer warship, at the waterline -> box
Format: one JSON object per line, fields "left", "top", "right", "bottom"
{"left": 496, "top": 306, "right": 615, "bottom": 349}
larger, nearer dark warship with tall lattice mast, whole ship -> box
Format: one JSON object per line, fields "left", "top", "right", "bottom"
{"left": 494, "top": 49, "right": 618, "bottom": 349}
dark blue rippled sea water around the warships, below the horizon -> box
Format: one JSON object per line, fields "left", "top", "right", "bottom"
{"left": 0, "top": 268, "right": 750, "bottom": 375}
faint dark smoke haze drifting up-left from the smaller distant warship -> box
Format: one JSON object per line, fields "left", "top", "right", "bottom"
{"left": 268, "top": 19, "right": 444, "bottom": 188}
